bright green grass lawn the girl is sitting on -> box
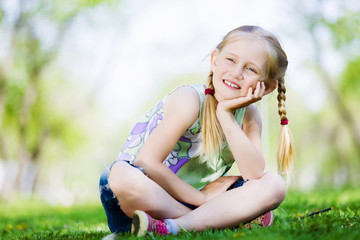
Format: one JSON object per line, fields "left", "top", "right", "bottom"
{"left": 0, "top": 188, "right": 360, "bottom": 240}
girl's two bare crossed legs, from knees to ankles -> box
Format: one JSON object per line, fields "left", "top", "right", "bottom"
{"left": 109, "top": 161, "right": 286, "bottom": 231}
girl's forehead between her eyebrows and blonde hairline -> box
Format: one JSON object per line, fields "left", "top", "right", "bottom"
{"left": 221, "top": 36, "right": 267, "bottom": 67}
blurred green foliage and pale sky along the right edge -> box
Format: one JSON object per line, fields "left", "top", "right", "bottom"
{"left": 288, "top": 0, "right": 360, "bottom": 186}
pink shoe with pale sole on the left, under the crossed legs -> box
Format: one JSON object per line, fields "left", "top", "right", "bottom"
{"left": 131, "top": 210, "right": 168, "bottom": 237}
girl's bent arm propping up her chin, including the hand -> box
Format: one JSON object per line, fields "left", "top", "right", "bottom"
{"left": 216, "top": 81, "right": 265, "bottom": 179}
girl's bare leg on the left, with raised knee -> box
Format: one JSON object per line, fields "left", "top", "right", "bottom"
{"left": 108, "top": 161, "right": 191, "bottom": 218}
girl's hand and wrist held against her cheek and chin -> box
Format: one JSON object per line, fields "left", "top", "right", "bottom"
{"left": 217, "top": 81, "right": 265, "bottom": 113}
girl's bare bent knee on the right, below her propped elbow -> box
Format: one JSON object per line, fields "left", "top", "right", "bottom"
{"left": 263, "top": 172, "right": 286, "bottom": 209}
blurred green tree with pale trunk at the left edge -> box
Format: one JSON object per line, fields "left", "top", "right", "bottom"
{"left": 0, "top": 0, "right": 116, "bottom": 198}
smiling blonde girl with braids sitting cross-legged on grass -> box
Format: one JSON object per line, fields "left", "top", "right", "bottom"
{"left": 100, "top": 26, "right": 293, "bottom": 236}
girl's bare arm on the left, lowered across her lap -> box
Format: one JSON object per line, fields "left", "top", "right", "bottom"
{"left": 135, "top": 87, "right": 206, "bottom": 206}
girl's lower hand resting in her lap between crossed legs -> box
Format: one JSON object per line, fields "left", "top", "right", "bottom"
{"left": 201, "top": 176, "right": 240, "bottom": 202}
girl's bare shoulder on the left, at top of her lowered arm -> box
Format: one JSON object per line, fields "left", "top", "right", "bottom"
{"left": 164, "top": 86, "right": 200, "bottom": 125}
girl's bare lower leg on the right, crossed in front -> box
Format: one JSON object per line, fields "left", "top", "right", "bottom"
{"left": 175, "top": 173, "right": 286, "bottom": 231}
